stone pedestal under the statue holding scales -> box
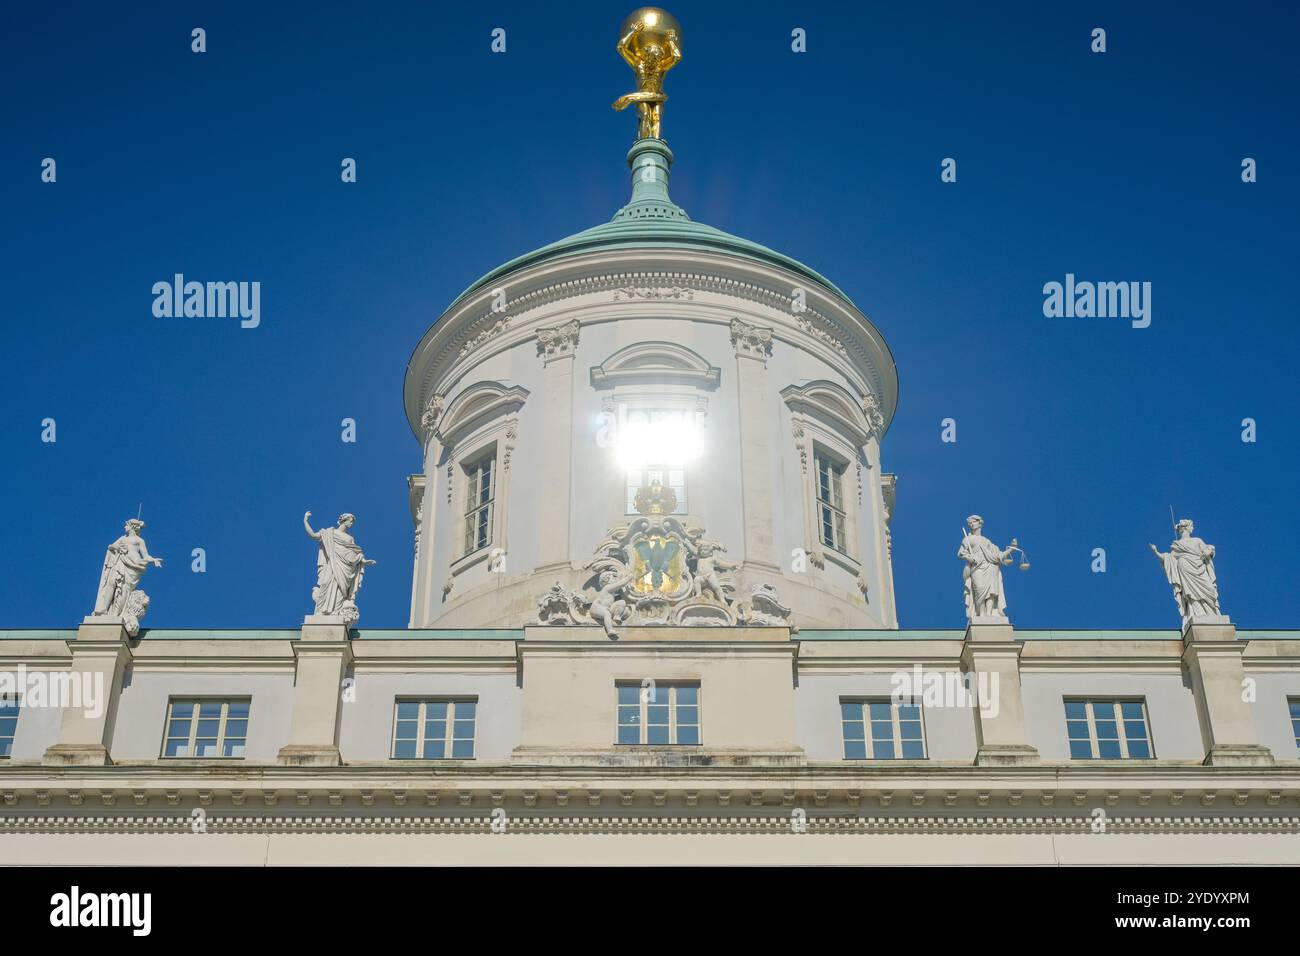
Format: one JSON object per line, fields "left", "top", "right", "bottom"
{"left": 962, "top": 618, "right": 1039, "bottom": 766}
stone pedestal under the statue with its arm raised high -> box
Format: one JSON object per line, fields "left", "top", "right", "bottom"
{"left": 277, "top": 614, "right": 352, "bottom": 766}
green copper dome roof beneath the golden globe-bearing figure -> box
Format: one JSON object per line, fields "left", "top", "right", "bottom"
{"left": 452, "top": 139, "right": 849, "bottom": 304}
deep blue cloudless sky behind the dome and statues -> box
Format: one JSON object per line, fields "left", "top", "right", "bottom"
{"left": 0, "top": 0, "right": 1300, "bottom": 628}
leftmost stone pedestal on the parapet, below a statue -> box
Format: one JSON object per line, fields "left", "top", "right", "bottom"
{"left": 42, "top": 617, "right": 131, "bottom": 766}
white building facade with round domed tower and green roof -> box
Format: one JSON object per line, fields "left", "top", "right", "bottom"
{"left": 0, "top": 139, "right": 1300, "bottom": 865}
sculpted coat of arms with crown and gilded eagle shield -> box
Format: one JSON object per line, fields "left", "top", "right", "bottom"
{"left": 537, "top": 481, "right": 796, "bottom": 640}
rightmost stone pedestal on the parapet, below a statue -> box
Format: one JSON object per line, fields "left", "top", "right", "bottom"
{"left": 1183, "top": 617, "right": 1273, "bottom": 766}
